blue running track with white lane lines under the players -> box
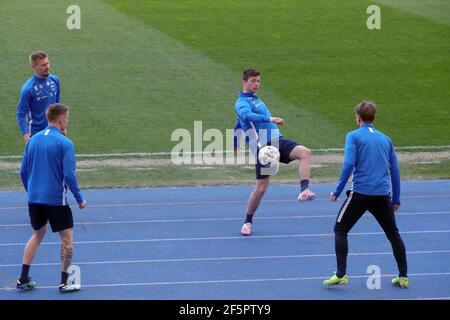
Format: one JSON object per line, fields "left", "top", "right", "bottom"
{"left": 0, "top": 180, "right": 450, "bottom": 300}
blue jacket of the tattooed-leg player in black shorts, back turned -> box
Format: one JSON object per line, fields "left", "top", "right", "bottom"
{"left": 20, "top": 126, "right": 83, "bottom": 206}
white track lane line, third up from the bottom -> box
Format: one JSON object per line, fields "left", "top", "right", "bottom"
{"left": 0, "top": 230, "right": 450, "bottom": 247}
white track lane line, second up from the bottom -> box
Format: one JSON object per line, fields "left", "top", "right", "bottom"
{"left": 0, "top": 250, "right": 450, "bottom": 268}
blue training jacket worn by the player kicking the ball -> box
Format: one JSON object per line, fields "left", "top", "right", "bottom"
{"left": 234, "top": 92, "right": 283, "bottom": 145}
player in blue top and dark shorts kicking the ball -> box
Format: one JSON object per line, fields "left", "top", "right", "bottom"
{"left": 235, "top": 69, "right": 316, "bottom": 236}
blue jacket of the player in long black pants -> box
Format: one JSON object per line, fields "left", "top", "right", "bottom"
{"left": 333, "top": 124, "right": 400, "bottom": 204}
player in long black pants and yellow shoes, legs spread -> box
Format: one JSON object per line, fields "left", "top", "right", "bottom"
{"left": 323, "top": 101, "right": 408, "bottom": 288}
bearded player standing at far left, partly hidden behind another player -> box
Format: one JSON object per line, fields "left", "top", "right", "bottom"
{"left": 16, "top": 51, "right": 60, "bottom": 142}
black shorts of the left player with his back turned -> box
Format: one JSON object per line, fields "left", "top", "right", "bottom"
{"left": 28, "top": 203, "right": 73, "bottom": 232}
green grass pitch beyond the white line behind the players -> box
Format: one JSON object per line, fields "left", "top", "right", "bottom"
{"left": 0, "top": 0, "right": 450, "bottom": 156}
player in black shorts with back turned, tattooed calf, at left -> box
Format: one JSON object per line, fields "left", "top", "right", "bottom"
{"left": 17, "top": 103, "right": 86, "bottom": 293}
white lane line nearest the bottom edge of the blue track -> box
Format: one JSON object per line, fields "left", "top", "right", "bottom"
{"left": 0, "top": 272, "right": 450, "bottom": 291}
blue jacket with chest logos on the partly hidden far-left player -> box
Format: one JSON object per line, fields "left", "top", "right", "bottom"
{"left": 16, "top": 74, "right": 60, "bottom": 136}
